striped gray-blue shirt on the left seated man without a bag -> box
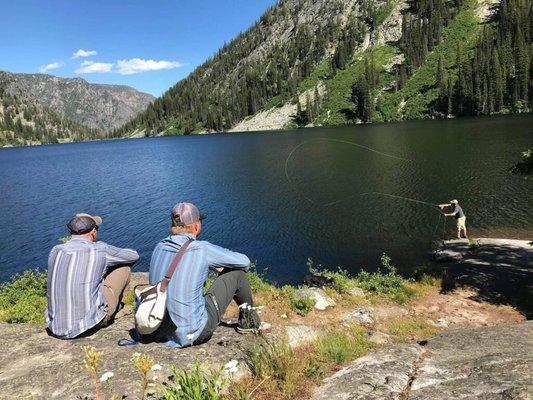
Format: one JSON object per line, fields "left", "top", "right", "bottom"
{"left": 45, "top": 236, "right": 139, "bottom": 339}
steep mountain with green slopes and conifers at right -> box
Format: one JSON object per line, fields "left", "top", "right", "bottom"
{"left": 115, "top": 0, "right": 533, "bottom": 136}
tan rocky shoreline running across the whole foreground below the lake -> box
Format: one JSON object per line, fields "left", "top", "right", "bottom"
{"left": 0, "top": 239, "right": 533, "bottom": 400}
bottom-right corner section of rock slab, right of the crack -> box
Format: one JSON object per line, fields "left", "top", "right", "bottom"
{"left": 408, "top": 322, "right": 533, "bottom": 400}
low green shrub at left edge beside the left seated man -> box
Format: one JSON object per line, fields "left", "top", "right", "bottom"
{"left": 0, "top": 270, "right": 47, "bottom": 323}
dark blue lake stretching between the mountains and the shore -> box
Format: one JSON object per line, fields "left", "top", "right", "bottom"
{"left": 0, "top": 115, "right": 533, "bottom": 283}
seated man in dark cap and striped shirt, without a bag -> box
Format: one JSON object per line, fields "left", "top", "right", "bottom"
{"left": 46, "top": 213, "right": 139, "bottom": 339}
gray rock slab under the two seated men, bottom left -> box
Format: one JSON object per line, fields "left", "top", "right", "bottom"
{"left": 0, "top": 316, "right": 251, "bottom": 400}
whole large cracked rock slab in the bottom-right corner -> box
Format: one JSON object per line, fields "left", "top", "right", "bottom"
{"left": 313, "top": 322, "right": 533, "bottom": 400}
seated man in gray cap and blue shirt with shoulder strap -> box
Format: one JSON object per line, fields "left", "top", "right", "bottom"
{"left": 149, "top": 203, "right": 269, "bottom": 347}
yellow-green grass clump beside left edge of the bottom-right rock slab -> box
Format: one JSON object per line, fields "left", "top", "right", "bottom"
{"left": 316, "top": 325, "right": 372, "bottom": 364}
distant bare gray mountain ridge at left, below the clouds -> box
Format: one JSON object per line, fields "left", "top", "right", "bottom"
{"left": 0, "top": 72, "right": 154, "bottom": 131}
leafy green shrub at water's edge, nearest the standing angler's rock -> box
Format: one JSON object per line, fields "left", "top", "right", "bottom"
{"left": 356, "top": 253, "right": 413, "bottom": 304}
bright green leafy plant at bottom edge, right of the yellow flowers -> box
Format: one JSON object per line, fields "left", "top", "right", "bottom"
{"left": 159, "top": 364, "right": 227, "bottom": 400}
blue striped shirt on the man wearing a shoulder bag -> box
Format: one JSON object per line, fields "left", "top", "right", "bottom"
{"left": 149, "top": 234, "right": 250, "bottom": 347}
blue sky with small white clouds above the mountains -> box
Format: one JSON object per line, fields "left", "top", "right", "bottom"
{"left": 0, "top": 0, "right": 276, "bottom": 96}
